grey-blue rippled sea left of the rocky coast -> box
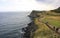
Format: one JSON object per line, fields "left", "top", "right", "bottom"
{"left": 0, "top": 12, "right": 31, "bottom": 38}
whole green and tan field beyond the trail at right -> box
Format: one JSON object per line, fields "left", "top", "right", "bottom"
{"left": 43, "top": 16, "right": 60, "bottom": 27}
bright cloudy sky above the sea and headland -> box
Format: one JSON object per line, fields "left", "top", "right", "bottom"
{"left": 0, "top": 0, "right": 60, "bottom": 11}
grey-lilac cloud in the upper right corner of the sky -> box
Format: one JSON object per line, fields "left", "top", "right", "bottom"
{"left": 36, "top": 0, "right": 60, "bottom": 7}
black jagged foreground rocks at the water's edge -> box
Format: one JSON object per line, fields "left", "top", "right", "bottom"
{"left": 22, "top": 21, "right": 37, "bottom": 38}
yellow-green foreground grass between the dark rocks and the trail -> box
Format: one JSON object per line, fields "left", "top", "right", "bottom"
{"left": 33, "top": 18, "right": 60, "bottom": 38}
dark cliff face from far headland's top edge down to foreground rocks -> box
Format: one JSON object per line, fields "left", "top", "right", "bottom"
{"left": 22, "top": 10, "right": 45, "bottom": 38}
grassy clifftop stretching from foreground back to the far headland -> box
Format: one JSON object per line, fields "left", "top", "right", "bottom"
{"left": 31, "top": 8, "right": 60, "bottom": 38}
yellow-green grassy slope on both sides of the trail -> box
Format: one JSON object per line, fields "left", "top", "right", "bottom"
{"left": 34, "top": 11, "right": 60, "bottom": 38}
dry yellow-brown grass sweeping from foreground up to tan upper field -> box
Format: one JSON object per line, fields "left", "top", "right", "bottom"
{"left": 33, "top": 11, "right": 60, "bottom": 38}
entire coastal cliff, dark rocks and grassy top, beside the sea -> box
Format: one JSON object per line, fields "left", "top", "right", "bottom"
{"left": 22, "top": 7, "right": 60, "bottom": 38}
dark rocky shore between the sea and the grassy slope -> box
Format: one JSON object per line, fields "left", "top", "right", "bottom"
{"left": 22, "top": 11, "right": 37, "bottom": 38}
